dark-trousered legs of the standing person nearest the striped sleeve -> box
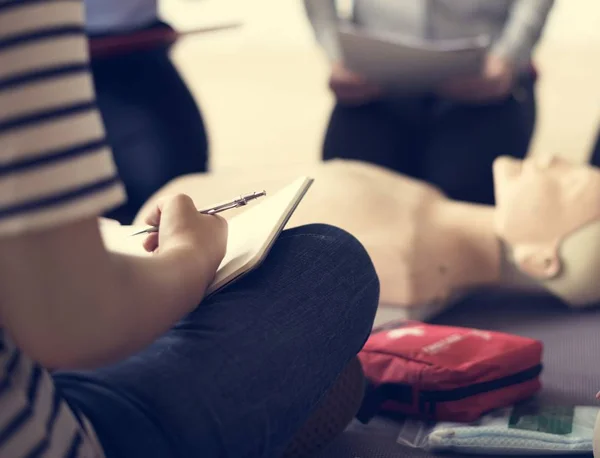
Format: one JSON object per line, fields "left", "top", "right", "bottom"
{"left": 92, "top": 48, "right": 208, "bottom": 223}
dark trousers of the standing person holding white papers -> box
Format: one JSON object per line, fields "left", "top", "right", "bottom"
{"left": 323, "top": 75, "right": 536, "bottom": 204}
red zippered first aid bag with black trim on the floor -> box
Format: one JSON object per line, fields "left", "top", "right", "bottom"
{"left": 358, "top": 321, "right": 542, "bottom": 422}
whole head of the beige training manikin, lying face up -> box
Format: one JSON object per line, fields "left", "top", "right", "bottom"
{"left": 494, "top": 157, "right": 600, "bottom": 307}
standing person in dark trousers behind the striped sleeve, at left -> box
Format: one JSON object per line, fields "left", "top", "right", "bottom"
{"left": 84, "top": 0, "right": 209, "bottom": 224}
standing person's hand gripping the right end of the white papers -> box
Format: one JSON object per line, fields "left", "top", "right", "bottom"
{"left": 438, "top": 54, "right": 515, "bottom": 103}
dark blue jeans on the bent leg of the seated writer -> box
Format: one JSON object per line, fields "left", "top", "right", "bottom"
{"left": 54, "top": 225, "right": 379, "bottom": 458}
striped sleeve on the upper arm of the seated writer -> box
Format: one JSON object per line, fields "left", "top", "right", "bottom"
{"left": 0, "top": 0, "right": 124, "bottom": 234}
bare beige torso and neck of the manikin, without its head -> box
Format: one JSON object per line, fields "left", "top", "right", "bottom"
{"left": 140, "top": 161, "right": 499, "bottom": 307}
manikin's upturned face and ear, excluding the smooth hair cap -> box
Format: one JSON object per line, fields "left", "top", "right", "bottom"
{"left": 494, "top": 157, "right": 600, "bottom": 279}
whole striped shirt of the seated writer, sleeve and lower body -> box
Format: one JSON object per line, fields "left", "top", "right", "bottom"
{"left": 0, "top": 0, "right": 124, "bottom": 458}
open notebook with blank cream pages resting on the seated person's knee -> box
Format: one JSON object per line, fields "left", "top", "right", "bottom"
{"left": 100, "top": 177, "right": 313, "bottom": 295}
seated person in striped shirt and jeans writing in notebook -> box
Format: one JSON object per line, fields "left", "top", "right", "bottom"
{"left": 0, "top": 0, "right": 379, "bottom": 458}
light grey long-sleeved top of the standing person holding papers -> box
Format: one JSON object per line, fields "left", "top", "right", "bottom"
{"left": 304, "top": 0, "right": 554, "bottom": 66}
